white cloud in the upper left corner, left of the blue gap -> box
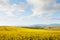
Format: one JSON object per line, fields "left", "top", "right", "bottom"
{"left": 0, "top": 0, "right": 25, "bottom": 16}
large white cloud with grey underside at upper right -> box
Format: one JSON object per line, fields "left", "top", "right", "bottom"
{"left": 27, "top": 0, "right": 60, "bottom": 16}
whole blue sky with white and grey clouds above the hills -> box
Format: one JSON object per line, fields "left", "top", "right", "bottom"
{"left": 0, "top": 0, "right": 60, "bottom": 26}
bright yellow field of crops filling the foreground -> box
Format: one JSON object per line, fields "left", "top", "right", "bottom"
{"left": 0, "top": 27, "right": 60, "bottom": 40}
